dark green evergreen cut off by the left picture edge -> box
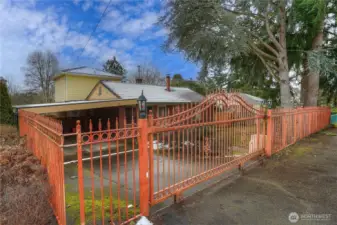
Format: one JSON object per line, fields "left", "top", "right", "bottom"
{"left": 0, "top": 77, "right": 13, "bottom": 124}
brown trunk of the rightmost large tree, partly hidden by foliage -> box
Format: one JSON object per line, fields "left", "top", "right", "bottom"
{"left": 306, "top": 20, "right": 324, "bottom": 106}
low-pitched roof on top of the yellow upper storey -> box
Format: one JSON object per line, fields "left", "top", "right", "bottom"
{"left": 53, "top": 66, "right": 122, "bottom": 80}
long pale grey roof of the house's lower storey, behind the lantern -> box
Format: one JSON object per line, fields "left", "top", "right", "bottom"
{"left": 101, "top": 81, "right": 203, "bottom": 103}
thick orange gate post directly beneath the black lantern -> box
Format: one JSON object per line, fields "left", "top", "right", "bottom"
{"left": 138, "top": 118, "right": 152, "bottom": 216}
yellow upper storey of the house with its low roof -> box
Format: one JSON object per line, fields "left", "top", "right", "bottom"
{"left": 53, "top": 66, "right": 123, "bottom": 102}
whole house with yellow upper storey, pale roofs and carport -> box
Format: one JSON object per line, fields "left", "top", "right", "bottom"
{"left": 15, "top": 67, "right": 263, "bottom": 133}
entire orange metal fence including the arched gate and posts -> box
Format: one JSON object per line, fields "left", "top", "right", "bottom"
{"left": 19, "top": 91, "right": 330, "bottom": 225}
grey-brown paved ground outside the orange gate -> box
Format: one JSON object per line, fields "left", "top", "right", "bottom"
{"left": 151, "top": 129, "right": 337, "bottom": 225}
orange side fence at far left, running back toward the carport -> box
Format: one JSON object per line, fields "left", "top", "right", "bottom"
{"left": 19, "top": 110, "right": 66, "bottom": 225}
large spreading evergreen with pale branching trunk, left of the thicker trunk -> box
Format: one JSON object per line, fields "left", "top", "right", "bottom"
{"left": 160, "top": 0, "right": 292, "bottom": 107}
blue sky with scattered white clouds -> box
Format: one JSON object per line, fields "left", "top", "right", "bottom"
{"left": 0, "top": 0, "right": 198, "bottom": 84}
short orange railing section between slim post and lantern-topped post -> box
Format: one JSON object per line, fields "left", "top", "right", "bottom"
{"left": 64, "top": 118, "right": 141, "bottom": 224}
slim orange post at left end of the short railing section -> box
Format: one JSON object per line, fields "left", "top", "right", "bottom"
{"left": 76, "top": 120, "right": 85, "bottom": 225}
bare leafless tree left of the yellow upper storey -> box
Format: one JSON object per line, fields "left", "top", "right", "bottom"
{"left": 24, "top": 51, "right": 58, "bottom": 102}
